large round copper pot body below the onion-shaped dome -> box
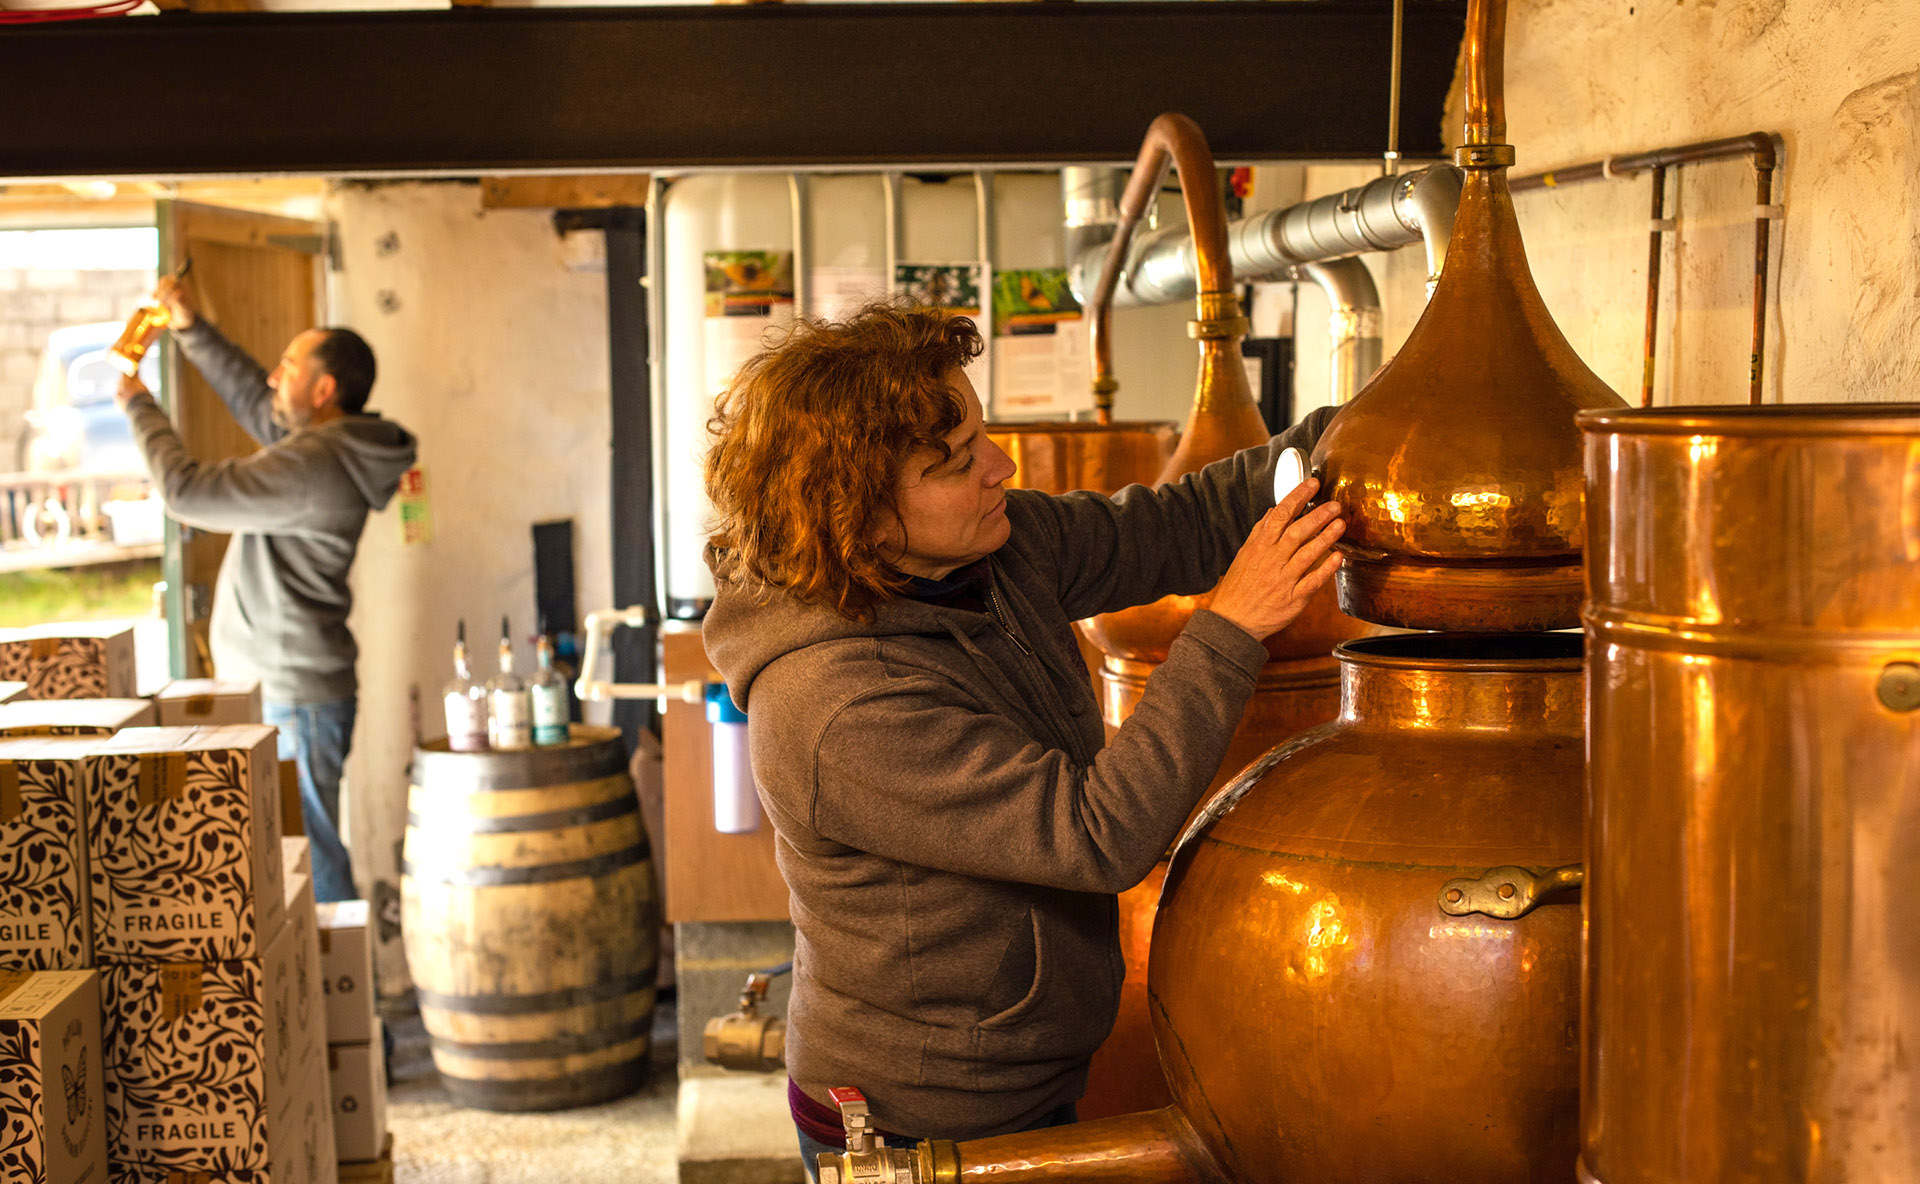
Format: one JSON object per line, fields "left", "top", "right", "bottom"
{"left": 1148, "top": 635, "right": 1584, "bottom": 1184}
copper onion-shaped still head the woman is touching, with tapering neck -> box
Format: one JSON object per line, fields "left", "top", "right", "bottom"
{"left": 1313, "top": 0, "right": 1626, "bottom": 631}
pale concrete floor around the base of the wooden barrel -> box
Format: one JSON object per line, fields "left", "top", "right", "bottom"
{"left": 388, "top": 1000, "right": 678, "bottom": 1184}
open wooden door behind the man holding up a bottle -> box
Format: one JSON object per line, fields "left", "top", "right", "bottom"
{"left": 156, "top": 201, "right": 324, "bottom": 677}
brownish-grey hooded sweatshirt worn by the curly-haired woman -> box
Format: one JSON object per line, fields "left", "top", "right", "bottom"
{"left": 705, "top": 404, "right": 1331, "bottom": 1138}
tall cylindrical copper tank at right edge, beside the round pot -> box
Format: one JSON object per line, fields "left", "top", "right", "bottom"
{"left": 1580, "top": 403, "right": 1920, "bottom": 1184}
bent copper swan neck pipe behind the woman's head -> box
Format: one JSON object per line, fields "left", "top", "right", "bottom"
{"left": 1087, "top": 111, "right": 1246, "bottom": 424}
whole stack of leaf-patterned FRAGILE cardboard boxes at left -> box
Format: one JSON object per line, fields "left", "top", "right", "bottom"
{"left": 0, "top": 629, "right": 336, "bottom": 1184}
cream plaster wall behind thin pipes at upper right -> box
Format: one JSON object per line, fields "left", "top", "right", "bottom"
{"left": 1351, "top": 0, "right": 1920, "bottom": 403}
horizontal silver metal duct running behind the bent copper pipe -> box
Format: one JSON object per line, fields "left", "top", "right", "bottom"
{"left": 1062, "top": 165, "right": 1461, "bottom": 307}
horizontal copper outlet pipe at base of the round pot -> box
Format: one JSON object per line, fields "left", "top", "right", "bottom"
{"left": 918, "top": 1107, "right": 1225, "bottom": 1184}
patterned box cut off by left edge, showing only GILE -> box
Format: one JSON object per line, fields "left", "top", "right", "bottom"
{"left": 0, "top": 739, "right": 98, "bottom": 971}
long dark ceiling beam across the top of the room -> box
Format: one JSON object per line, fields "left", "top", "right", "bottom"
{"left": 0, "top": 0, "right": 1465, "bottom": 177}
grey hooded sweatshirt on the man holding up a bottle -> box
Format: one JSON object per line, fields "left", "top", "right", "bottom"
{"left": 127, "top": 317, "right": 415, "bottom": 702}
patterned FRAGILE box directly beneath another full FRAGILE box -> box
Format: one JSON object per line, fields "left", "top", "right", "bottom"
{"left": 100, "top": 909, "right": 299, "bottom": 1171}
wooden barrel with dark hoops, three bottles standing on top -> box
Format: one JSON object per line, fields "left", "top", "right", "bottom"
{"left": 399, "top": 723, "right": 660, "bottom": 1111}
